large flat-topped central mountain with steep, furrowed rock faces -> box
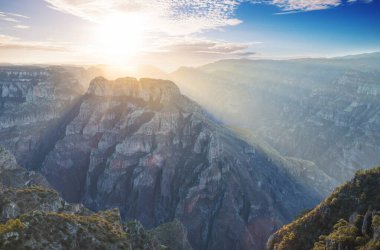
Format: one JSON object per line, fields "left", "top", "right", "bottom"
{"left": 41, "top": 77, "right": 316, "bottom": 249}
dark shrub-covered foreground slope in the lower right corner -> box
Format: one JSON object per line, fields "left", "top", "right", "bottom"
{"left": 268, "top": 167, "right": 380, "bottom": 250}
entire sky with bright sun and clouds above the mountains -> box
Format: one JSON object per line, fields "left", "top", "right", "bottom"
{"left": 0, "top": 0, "right": 380, "bottom": 71}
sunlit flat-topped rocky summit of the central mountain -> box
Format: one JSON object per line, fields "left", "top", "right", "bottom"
{"left": 87, "top": 77, "right": 180, "bottom": 103}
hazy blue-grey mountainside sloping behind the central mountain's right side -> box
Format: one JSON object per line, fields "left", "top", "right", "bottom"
{"left": 170, "top": 53, "right": 380, "bottom": 195}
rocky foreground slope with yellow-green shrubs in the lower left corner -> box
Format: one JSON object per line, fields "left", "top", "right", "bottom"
{"left": 0, "top": 148, "right": 162, "bottom": 250}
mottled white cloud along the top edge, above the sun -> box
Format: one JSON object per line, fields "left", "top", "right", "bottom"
{"left": 45, "top": 0, "right": 241, "bottom": 35}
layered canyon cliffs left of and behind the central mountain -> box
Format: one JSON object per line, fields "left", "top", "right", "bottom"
{"left": 0, "top": 66, "right": 99, "bottom": 169}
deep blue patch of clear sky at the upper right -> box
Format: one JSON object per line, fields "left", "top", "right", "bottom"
{"left": 218, "top": 1, "right": 380, "bottom": 57}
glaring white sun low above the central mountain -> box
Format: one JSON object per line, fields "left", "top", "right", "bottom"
{"left": 91, "top": 14, "right": 145, "bottom": 65}
